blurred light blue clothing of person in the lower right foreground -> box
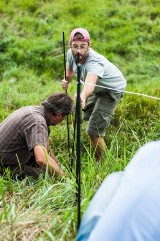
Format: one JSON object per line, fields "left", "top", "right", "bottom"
{"left": 77, "top": 141, "right": 160, "bottom": 241}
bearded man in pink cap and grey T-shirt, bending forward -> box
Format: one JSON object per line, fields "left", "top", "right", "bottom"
{"left": 61, "top": 28, "right": 126, "bottom": 160}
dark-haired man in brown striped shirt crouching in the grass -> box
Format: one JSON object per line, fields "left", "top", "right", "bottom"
{"left": 0, "top": 93, "right": 73, "bottom": 178}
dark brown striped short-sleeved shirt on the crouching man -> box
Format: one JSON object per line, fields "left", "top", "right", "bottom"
{"left": 0, "top": 105, "right": 49, "bottom": 164}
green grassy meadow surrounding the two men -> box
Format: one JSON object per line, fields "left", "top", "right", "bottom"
{"left": 0, "top": 0, "right": 160, "bottom": 241}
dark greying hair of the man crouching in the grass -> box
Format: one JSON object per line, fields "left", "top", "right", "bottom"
{"left": 42, "top": 93, "right": 74, "bottom": 116}
